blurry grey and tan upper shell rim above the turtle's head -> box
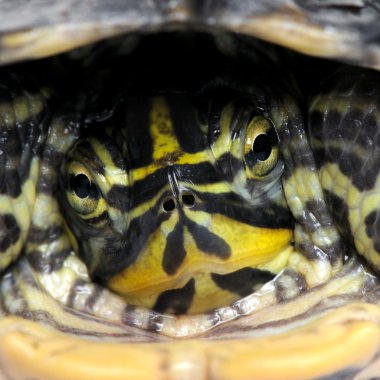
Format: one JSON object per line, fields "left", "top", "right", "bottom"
{"left": 0, "top": 0, "right": 380, "bottom": 69}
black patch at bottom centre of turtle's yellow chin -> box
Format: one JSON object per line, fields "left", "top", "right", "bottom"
{"left": 153, "top": 279, "right": 195, "bottom": 315}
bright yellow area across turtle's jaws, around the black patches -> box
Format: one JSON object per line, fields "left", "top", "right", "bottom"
{"left": 108, "top": 215, "right": 293, "bottom": 313}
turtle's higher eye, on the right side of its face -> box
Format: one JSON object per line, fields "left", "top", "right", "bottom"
{"left": 243, "top": 116, "right": 279, "bottom": 178}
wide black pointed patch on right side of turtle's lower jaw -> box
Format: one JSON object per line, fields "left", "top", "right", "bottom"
{"left": 211, "top": 267, "right": 275, "bottom": 297}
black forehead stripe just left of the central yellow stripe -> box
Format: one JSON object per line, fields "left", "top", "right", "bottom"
{"left": 125, "top": 99, "right": 153, "bottom": 169}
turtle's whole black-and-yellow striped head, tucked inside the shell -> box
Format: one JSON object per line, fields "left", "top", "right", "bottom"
{"left": 62, "top": 92, "right": 292, "bottom": 314}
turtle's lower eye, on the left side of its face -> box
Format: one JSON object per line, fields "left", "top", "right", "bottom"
{"left": 66, "top": 161, "right": 103, "bottom": 219}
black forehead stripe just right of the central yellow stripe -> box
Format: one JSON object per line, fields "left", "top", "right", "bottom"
{"left": 168, "top": 96, "right": 205, "bottom": 153}
